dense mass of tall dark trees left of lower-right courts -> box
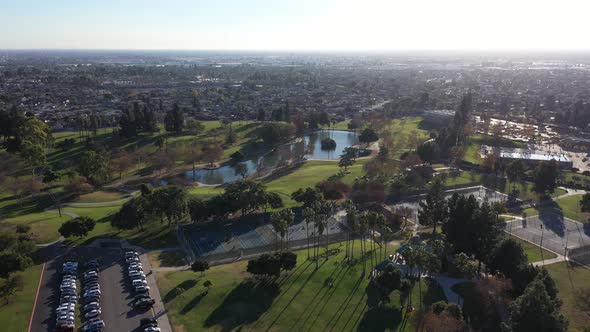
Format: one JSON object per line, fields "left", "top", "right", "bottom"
{"left": 418, "top": 181, "right": 568, "bottom": 331}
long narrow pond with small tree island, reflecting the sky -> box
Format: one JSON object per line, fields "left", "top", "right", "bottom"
{"left": 185, "top": 130, "right": 358, "bottom": 184}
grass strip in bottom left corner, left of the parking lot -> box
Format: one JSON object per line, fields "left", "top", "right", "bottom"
{"left": 0, "top": 265, "right": 42, "bottom": 331}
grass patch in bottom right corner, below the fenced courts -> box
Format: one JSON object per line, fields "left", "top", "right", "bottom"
{"left": 545, "top": 262, "right": 590, "bottom": 332}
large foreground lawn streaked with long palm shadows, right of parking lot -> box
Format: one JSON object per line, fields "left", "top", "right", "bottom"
{"left": 156, "top": 243, "right": 444, "bottom": 331}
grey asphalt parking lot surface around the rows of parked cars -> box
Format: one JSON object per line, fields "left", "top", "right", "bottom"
{"left": 31, "top": 246, "right": 170, "bottom": 332}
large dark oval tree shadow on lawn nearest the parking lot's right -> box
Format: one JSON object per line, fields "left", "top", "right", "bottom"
{"left": 205, "top": 280, "right": 280, "bottom": 331}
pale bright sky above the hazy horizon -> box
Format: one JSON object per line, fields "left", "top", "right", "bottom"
{"left": 0, "top": 0, "right": 590, "bottom": 51}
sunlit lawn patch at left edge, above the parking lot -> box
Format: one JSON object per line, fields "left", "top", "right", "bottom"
{"left": 0, "top": 212, "right": 71, "bottom": 243}
